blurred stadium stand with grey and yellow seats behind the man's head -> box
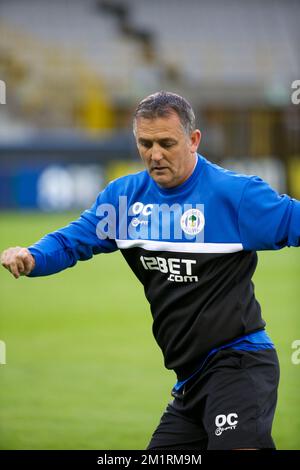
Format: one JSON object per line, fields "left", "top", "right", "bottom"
{"left": 0, "top": 0, "right": 300, "bottom": 206}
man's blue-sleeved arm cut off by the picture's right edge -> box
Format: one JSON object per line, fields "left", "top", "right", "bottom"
{"left": 238, "top": 177, "right": 300, "bottom": 250}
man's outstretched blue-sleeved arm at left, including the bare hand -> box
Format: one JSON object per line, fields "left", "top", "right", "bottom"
{"left": 1, "top": 186, "right": 117, "bottom": 278}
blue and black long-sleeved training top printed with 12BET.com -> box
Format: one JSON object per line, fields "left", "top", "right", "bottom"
{"left": 29, "top": 155, "right": 300, "bottom": 382}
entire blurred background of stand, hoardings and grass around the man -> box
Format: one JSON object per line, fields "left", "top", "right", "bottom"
{"left": 0, "top": 0, "right": 300, "bottom": 449}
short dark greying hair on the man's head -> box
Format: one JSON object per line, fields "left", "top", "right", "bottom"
{"left": 133, "top": 91, "right": 195, "bottom": 135}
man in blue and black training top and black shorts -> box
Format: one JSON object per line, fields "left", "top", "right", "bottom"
{"left": 1, "top": 92, "right": 300, "bottom": 449}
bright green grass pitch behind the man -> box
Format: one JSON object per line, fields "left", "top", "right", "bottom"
{"left": 0, "top": 213, "right": 300, "bottom": 450}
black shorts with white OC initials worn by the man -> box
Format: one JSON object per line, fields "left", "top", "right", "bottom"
{"left": 147, "top": 348, "right": 279, "bottom": 450}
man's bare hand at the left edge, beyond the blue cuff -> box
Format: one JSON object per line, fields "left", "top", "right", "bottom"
{"left": 1, "top": 246, "right": 35, "bottom": 279}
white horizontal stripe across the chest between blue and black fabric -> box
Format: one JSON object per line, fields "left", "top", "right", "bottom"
{"left": 116, "top": 239, "right": 243, "bottom": 253}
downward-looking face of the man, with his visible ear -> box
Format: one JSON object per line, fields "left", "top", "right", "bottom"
{"left": 135, "top": 112, "right": 201, "bottom": 188}
